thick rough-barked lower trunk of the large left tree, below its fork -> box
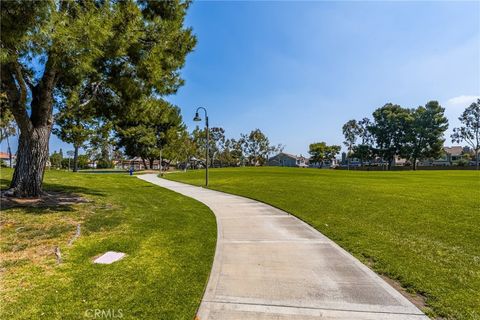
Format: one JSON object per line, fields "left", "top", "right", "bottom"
{"left": 10, "top": 125, "right": 51, "bottom": 197}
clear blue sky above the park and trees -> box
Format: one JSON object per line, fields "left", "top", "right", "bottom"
{"left": 1, "top": 1, "right": 480, "bottom": 154}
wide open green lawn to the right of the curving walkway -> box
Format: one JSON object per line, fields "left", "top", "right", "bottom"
{"left": 167, "top": 167, "right": 480, "bottom": 319}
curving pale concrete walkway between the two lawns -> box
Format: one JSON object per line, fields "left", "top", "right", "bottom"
{"left": 138, "top": 174, "right": 428, "bottom": 320}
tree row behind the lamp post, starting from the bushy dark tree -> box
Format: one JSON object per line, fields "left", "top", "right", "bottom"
{"left": 117, "top": 124, "right": 282, "bottom": 168}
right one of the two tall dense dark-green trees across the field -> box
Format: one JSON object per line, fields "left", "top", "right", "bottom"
{"left": 402, "top": 101, "right": 448, "bottom": 170}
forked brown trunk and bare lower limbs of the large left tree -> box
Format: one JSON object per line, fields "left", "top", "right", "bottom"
{"left": 0, "top": 56, "right": 57, "bottom": 197}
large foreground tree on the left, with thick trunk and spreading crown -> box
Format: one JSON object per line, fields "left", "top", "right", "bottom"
{"left": 0, "top": 0, "right": 195, "bottom": 196}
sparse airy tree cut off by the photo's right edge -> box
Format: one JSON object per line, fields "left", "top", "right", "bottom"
{"left": 451, "top": 99, "right": 480, "bottom": 170}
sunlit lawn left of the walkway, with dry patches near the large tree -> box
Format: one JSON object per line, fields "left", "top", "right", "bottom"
{"left": 0, "top": 169, "right": 216, "bottom": 319}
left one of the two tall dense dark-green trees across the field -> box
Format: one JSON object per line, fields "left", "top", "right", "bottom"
{"left": 370, "top": 103, "right": 410, "bottom": 169}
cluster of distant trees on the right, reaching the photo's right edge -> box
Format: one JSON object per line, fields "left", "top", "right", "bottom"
{"left": 342, "top": 99, "right": 480, "bottom": 170}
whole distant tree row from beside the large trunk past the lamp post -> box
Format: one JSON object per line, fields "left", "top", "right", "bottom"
{"left": 50, "top": 124, "right": 283, "bottom": 171}
